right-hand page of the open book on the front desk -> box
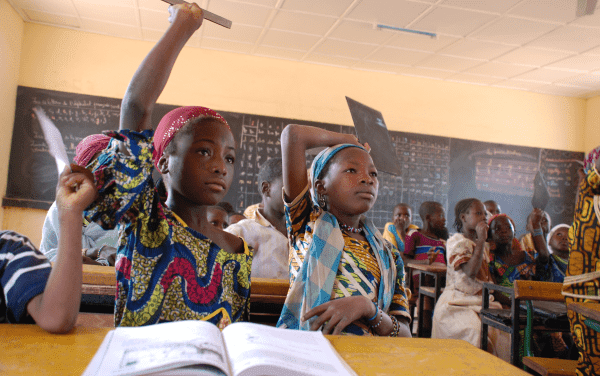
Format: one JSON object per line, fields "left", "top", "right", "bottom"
{"left": 223, "top": 323, "right": 353, "bottom": 376}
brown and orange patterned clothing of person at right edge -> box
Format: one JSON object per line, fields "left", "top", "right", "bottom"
{"left": 563, "top": 168, "right": 600, "bottom": 375}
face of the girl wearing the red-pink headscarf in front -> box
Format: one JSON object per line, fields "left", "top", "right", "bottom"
{"left": 165, "top": 120, "right": 235, "bottom": 205}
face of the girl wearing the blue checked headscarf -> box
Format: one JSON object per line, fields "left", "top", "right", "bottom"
{"left": 320, "top": 147, "right": 379, "bottom": 215}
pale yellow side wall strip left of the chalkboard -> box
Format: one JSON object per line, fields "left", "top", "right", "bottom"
{"left": 0, "top": 0, "right": 24, "bottom": 229}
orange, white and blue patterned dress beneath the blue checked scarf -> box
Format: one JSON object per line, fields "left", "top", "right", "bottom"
{"left": 285, "top": 187, "right": 410, "bottom": 335}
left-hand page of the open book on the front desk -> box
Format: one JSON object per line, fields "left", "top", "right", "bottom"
{"left": 84, "top": 321, "right": 230, "bottom": 376}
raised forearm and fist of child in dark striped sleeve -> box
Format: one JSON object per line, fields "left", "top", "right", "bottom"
{"left": 27, "top": 164, "right": 96, "bottom": 333}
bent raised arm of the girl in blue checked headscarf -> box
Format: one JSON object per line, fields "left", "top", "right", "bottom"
{"left": 281, "top": 124, "right": 360, "bottom": 200}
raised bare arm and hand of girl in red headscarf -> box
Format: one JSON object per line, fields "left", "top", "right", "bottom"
{"left": 119, "top": 4, "right": 203, "bottom": 131}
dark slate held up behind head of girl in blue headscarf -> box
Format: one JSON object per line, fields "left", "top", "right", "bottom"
{"left": 346, "top": 97, "right": 402, "bottom": 175}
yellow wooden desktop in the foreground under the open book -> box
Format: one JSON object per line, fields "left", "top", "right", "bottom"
{"left": 0, "top": 324, "right": 528, "bottom": 376}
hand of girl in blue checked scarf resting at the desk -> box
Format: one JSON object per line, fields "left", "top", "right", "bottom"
{"left": 302, "top": 296, "right": 375, "bottom": 335}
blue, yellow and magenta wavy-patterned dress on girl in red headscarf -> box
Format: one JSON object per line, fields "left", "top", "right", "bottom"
{"left": 86, "top": 130, "right": 252, "bottom": 328}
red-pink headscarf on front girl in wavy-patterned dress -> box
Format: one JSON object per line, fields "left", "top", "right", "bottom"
{"left": 152, "top": 106, "right": 231, "bottom": 169}
